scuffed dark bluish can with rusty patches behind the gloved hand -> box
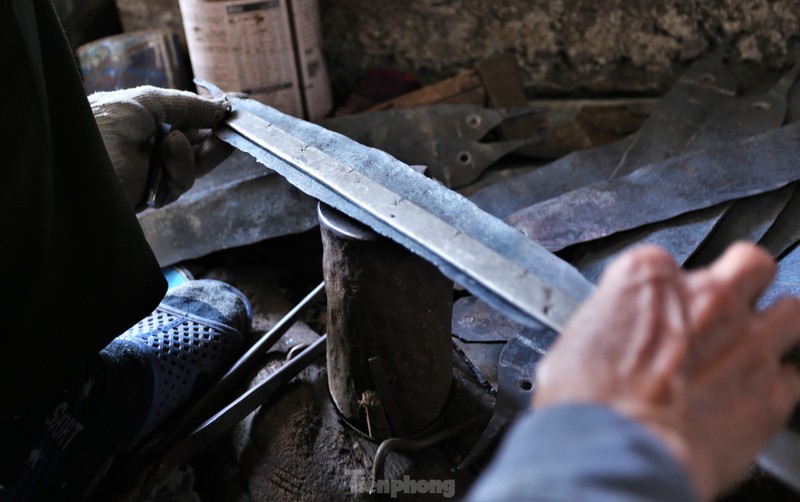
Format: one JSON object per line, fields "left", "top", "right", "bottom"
{"left": 75, "top": 29, "right": 194, "bottom": 94}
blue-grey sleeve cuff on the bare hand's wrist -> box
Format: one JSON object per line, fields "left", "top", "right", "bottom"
{"left": 465, "top": 404, "right": 699, "bottom": 502}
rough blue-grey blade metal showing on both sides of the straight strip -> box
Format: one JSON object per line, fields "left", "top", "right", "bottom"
{"left": 217, "top": 98, "right": 594, "bottom": 326}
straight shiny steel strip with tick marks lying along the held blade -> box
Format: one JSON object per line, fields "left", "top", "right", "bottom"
{"left": 226, "top": 109, "right": 580, "bottom": 330}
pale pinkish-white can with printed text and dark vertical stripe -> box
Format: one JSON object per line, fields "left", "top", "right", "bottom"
{"left": 180, "top": 0, "right": 333, "bottom": 120}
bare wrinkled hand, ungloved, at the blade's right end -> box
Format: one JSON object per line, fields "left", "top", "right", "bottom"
{"left": 534, "top": 243, "right": 800, "bottom": 500}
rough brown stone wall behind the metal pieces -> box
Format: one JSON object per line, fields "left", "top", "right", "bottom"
{"left": 320, "top": 0, "right": 800, "bottom": 99}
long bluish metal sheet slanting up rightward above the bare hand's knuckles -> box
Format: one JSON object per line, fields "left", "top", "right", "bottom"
{"left": 507, "top": 124, "right": 800, "bottom": 251}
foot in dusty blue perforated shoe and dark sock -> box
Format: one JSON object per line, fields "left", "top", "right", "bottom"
{"left": 0, "top": 280, "right": 252, "bottom": 501}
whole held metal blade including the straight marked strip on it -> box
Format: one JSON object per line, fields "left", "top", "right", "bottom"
{"left": 211, "top": 93, "right": 593, "bottom": 334}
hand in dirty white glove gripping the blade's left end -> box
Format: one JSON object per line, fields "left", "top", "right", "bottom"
{"left": 89, "top": 86, "right": 231, "bottom": 209}
